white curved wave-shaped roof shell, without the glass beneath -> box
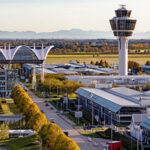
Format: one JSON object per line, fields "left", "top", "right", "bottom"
{"left": 0, "top": 45, "right": 54, "bottom": 60}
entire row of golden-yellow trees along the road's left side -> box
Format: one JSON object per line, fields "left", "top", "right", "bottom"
{"left": 11, "top": 86, "right": 80, "bottom": 150}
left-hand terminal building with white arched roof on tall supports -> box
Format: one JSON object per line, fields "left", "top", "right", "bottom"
{"left": 0, "top": 45, "right": 53, "bottom": 97}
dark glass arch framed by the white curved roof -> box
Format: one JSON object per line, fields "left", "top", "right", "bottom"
{"left": 13, "top": 46, "right": 38, "bottom": 61}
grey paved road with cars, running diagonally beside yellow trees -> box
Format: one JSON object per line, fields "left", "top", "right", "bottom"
{"left": 19, "top": 82, "right": 108, "bottom": 150}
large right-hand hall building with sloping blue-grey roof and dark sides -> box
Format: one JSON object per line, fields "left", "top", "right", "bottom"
{"left": 76, "top": 87, "right": 150, "bottom": 125}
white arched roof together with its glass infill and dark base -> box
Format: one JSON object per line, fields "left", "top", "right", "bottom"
{"left": 0, "top": 45, "right": 54, "bottom": 64}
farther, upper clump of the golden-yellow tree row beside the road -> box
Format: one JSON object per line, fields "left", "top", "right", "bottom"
{"left": 11, "top": 86, "right": 47, "bottom": 132}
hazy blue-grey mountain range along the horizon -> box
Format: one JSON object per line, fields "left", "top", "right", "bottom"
{"left": 0, "top": 29, "right": 150, "bottom": 39}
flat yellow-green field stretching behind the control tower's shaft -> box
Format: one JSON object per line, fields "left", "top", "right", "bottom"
{"left": 46, "top": 54, "right": 150, "bottom": 65}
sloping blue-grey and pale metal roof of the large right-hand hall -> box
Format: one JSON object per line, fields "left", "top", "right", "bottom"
{"left": 76, "top": 88, "right": 140, "bottom": 113}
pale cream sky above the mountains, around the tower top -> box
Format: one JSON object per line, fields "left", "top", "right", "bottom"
{"left": 0, "top": 0, "right": 150, "bottom": 32}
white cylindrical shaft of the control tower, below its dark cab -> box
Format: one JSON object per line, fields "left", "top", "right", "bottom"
{"left": 118, "top": 37, "right": 128, "bottom": 76}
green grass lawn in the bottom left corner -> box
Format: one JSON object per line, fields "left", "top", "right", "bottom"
{"left": 0, "top": 135, "right": 40, "bottom": 150}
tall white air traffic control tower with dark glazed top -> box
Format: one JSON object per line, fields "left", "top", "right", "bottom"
{"left": 110, "top": 5, "right": 136, "bottom": 75}
